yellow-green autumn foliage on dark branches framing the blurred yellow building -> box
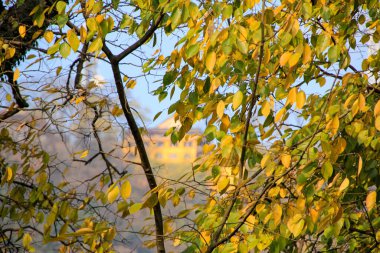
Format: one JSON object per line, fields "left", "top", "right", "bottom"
{"left": 0, "top": 0, "right": 380, "bottom": 252}
